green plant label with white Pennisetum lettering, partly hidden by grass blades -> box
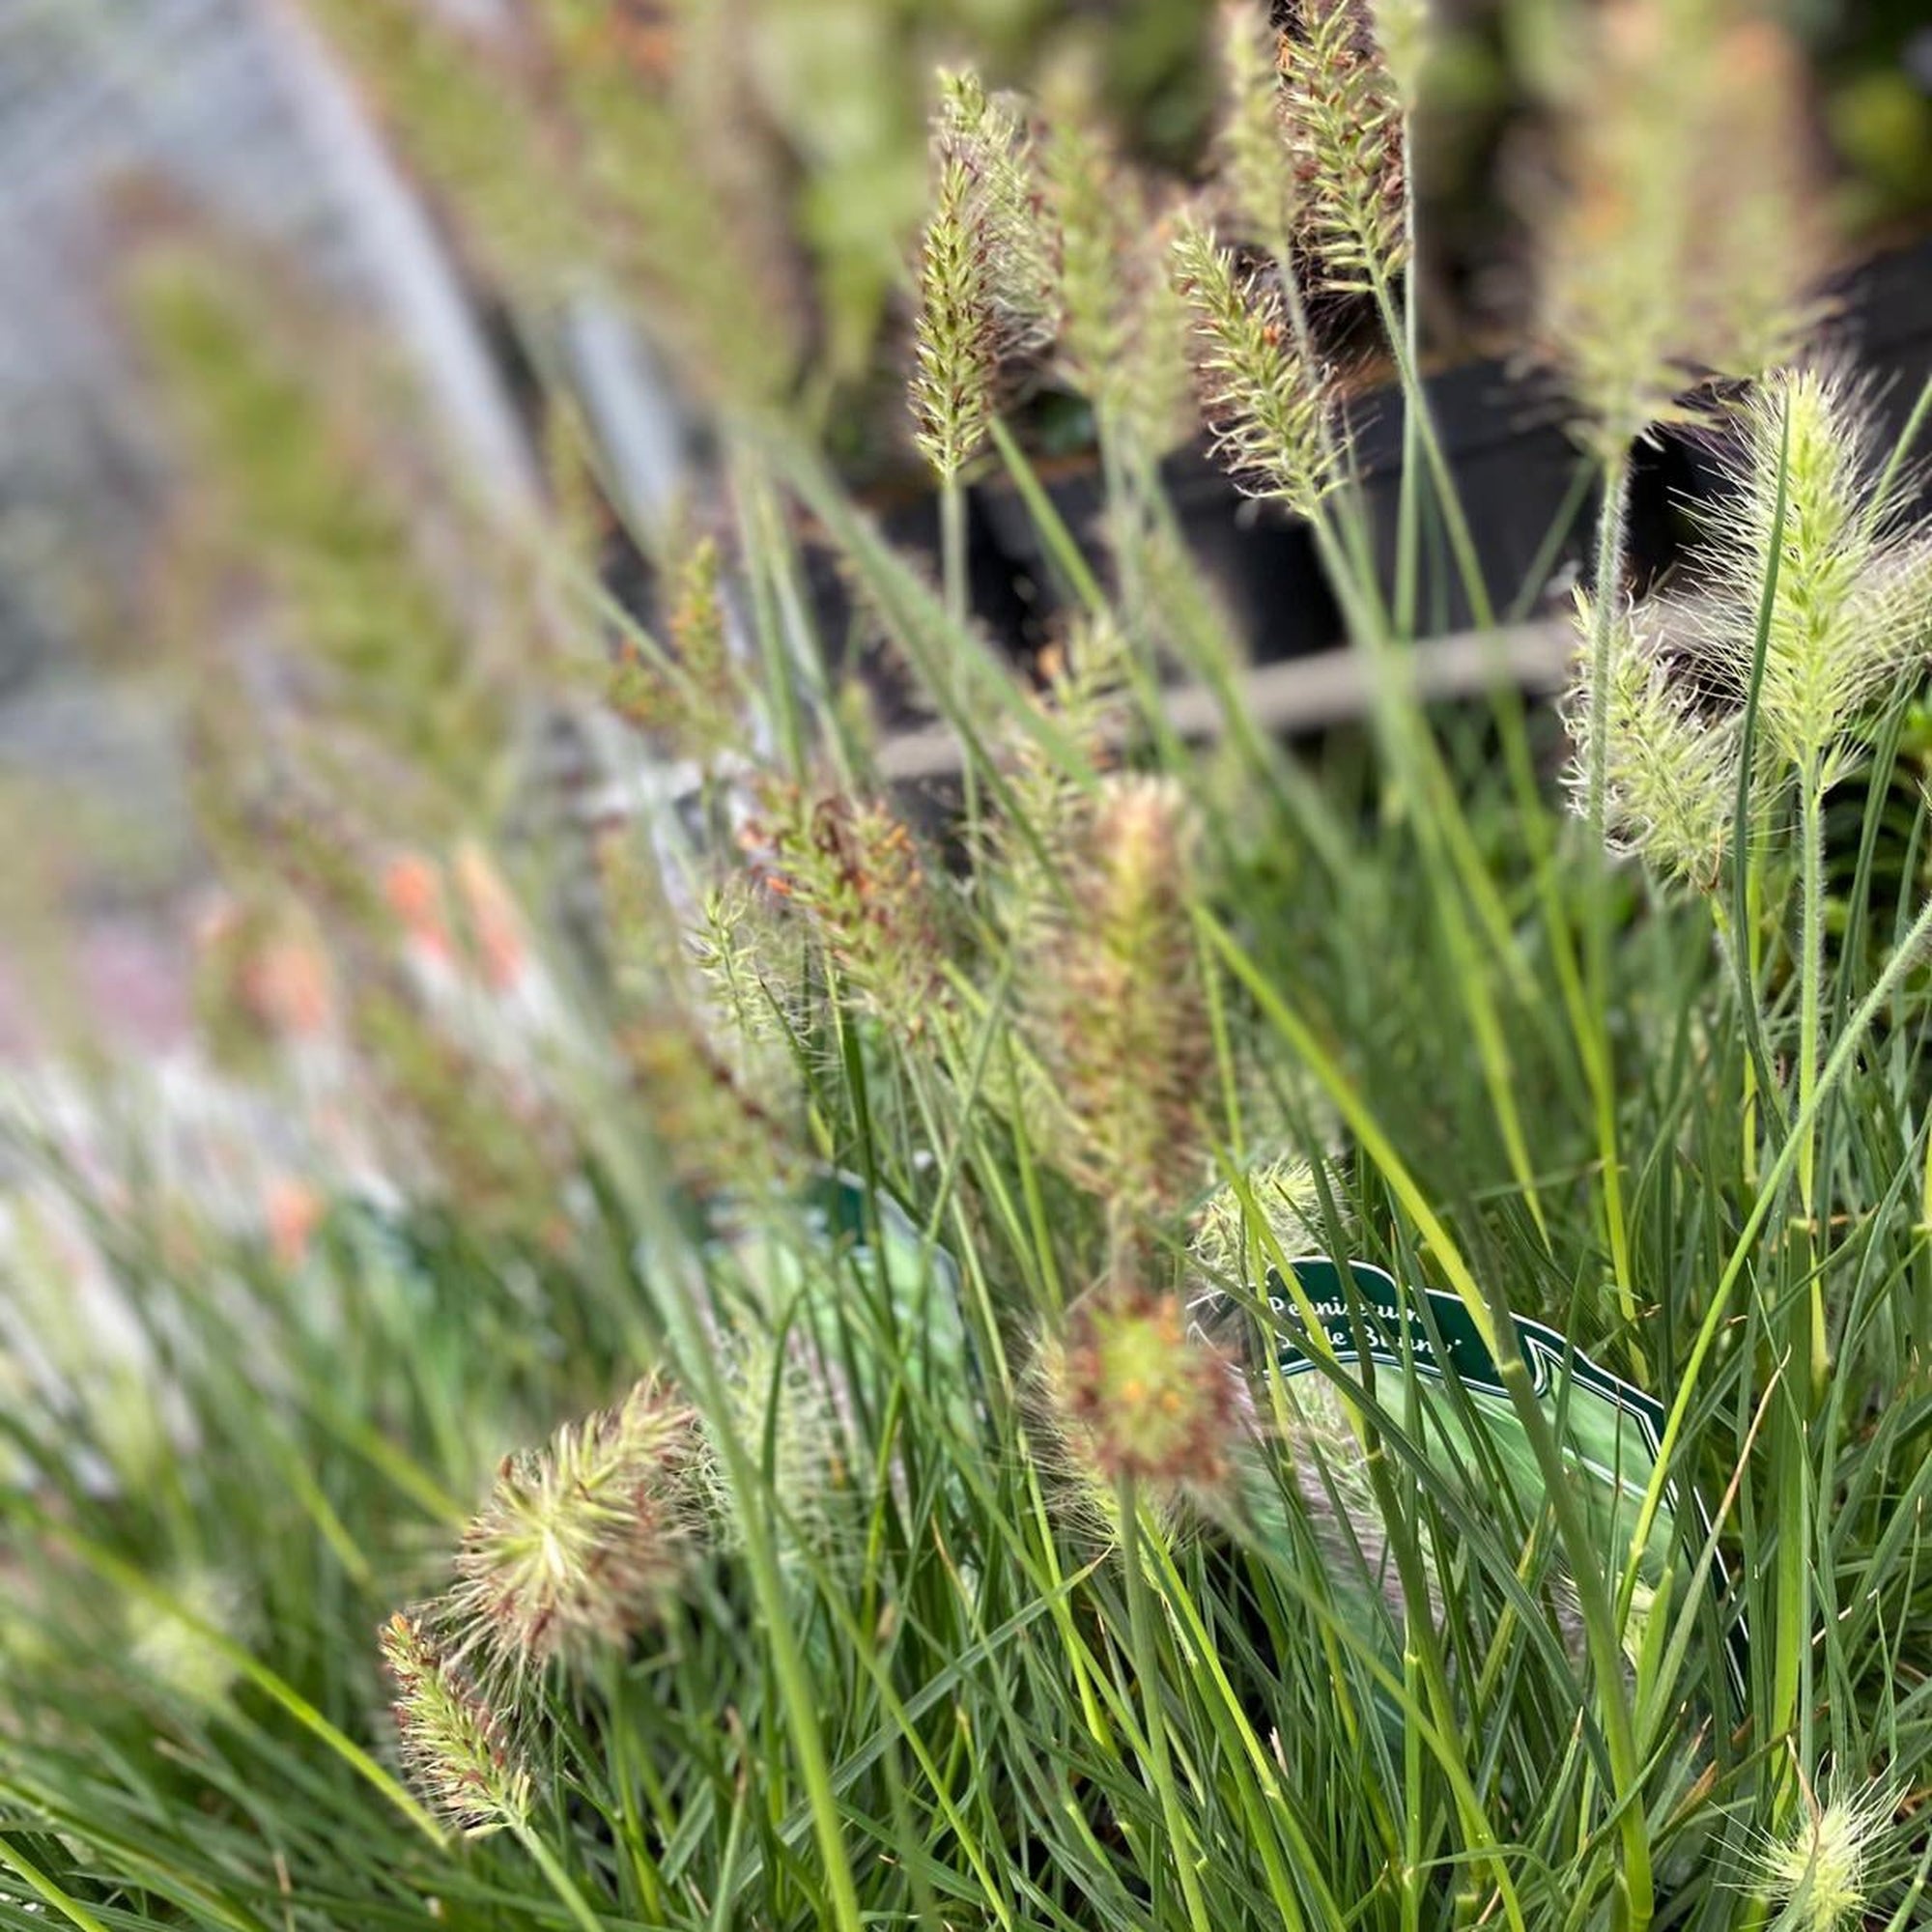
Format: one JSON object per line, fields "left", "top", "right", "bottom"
{"left": 1264, "top": 1256, "right": 1745, "bottom": 1696}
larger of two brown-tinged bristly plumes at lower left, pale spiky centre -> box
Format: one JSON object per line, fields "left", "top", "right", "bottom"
{"left": 448, "top": 1379, "right": 697, "bottom": 1683}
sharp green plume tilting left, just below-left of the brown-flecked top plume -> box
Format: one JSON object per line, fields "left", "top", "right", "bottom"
{"left": 1173, "top": 218, "right": 1339, "bottom": 516}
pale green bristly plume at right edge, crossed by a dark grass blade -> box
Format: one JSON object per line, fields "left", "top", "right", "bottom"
{"left": 1696, "top": 369, "right": 1932, "bottom": 782}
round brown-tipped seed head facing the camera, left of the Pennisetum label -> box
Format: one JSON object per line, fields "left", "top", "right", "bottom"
{"left": 1053, "top": 1289, "right": 1240, "bottom": 1488}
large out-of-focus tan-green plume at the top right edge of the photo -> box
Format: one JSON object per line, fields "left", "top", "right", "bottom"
{"left": 1530, "top": 0, "right": 1822, "bottom": 454}
